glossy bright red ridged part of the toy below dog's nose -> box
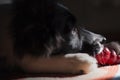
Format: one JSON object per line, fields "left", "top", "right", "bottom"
{"left": 95, "top": 47, "right": 120, "bottom": 65}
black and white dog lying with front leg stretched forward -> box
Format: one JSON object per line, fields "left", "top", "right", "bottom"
{"left": 1, "top": 0, "right": 117, "bottom": 73}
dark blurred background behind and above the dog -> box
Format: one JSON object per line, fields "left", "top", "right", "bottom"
{"left": 0, "top": 0, "right": 120, "bottom": 41}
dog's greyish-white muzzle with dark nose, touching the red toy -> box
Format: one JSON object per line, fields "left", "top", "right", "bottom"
{"left": 80, "top": 29, "right": 106, "bottom": 55}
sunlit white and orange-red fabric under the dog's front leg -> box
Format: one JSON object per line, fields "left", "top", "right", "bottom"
{"left": 16, "top": 65, "right": 120, "bottom": 80}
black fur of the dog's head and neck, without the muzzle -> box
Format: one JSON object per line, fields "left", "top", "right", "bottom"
{"left": 12, "top": 0, "right": 75, "bottom": 55}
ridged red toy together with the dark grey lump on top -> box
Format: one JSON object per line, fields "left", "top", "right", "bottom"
{"left": 95, "top": 42, "right": 120, "bottom": 66}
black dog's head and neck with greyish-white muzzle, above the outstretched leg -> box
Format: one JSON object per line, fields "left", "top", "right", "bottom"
{"left": 12, "top": 0, "right": 104, "bottom": 56}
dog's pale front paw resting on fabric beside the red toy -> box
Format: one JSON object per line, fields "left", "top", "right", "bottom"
{"left": 65, "top": 53, "right": 97, "bottom": 73}
